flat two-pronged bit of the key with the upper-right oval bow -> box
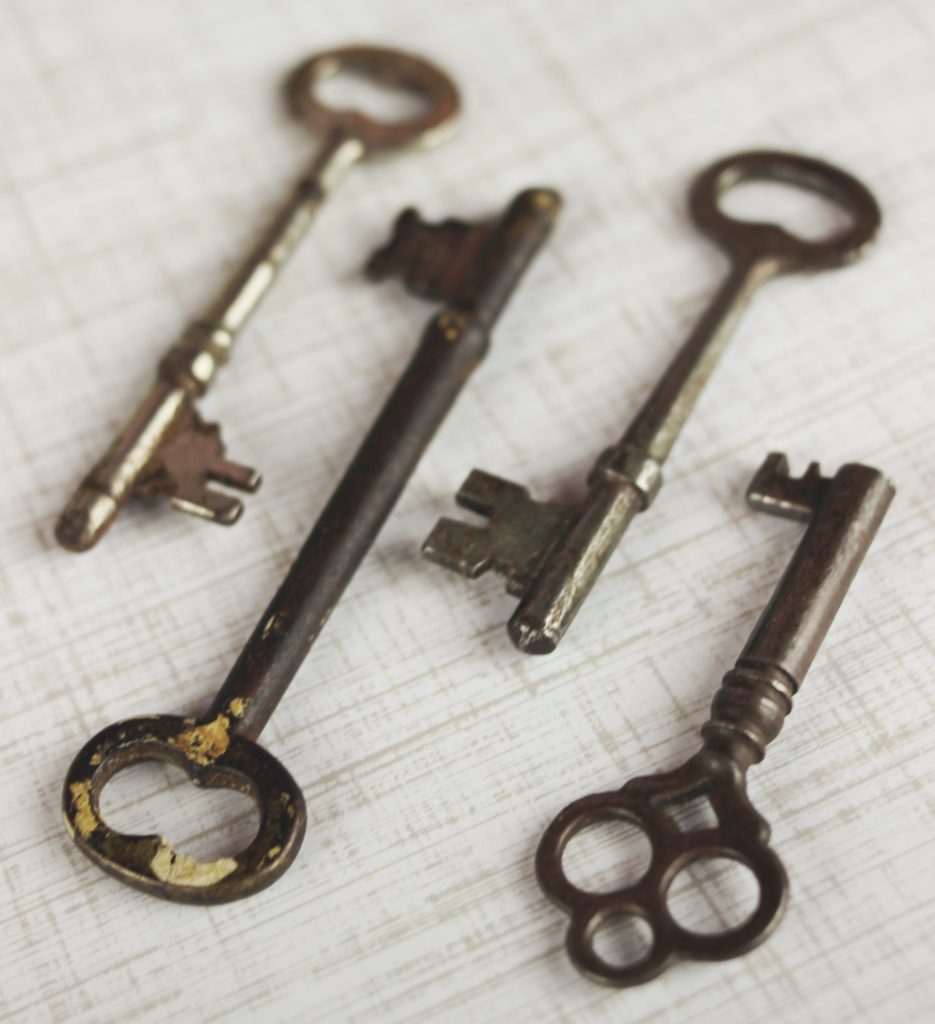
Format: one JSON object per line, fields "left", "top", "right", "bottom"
{"left": 422, "top": 469, "right": 571, "bottom": 597}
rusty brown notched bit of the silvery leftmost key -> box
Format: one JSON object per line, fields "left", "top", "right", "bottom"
{"left": 133, "top": 404, "right": 261, "bottom": 525}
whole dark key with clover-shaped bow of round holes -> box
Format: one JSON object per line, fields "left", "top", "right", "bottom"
{"left": 536, "top": 454, "right": 894, "bottom": 987}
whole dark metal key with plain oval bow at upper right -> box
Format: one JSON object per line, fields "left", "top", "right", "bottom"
{"left": 423, "top": 152, "right": 880, "bottom": 654}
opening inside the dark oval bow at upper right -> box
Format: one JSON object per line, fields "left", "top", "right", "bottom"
{"left": 718, "top": 178, "right": 856, "bottom": 242}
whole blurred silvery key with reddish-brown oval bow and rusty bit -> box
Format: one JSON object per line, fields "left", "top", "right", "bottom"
{"left": 55, "top": 46, "right": 460, "bottom": 551}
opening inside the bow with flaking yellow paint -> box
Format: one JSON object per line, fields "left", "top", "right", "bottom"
{"left": 100, "top": 761, "right": 260, "bottom": 863}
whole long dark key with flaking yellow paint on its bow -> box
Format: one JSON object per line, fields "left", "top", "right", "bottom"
{"left": 62, "top": 188, "right": 560, "bottom": 903}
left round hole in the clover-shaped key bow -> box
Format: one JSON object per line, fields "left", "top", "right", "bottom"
{"left": 561, "top": 818, "right": 652, "bottom": 897}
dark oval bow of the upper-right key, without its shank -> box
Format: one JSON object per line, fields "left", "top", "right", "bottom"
{"left": 689, "top": 150, "right": 881, "bottom": 270}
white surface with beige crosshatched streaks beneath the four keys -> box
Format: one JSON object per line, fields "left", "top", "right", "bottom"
{"left": 0, "top": 0, "right": 935, "bottom": 1024}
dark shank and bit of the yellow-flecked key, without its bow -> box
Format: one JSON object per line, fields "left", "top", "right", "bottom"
{"left": 208, "top": 188, "right": 560, "bottom": 737}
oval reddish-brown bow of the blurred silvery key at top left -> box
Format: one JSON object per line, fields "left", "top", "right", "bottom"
{"left": 289, "top": 46, "right": 461, "bottom": 152}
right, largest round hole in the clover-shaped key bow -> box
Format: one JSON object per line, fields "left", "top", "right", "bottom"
{"left": 666, "top": 857, "right": 760, "bottom": 935}
